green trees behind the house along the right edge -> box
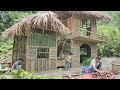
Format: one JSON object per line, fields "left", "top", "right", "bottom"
{"left": 97, "top": 11, "right": 120, "bottom": 57}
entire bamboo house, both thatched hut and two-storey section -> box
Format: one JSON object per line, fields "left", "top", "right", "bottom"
{"left": 2, "top": 11, "right": 111, "bottom": 71}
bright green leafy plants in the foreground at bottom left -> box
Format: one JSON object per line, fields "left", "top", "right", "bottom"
{"left": 0, "top": 69, "right": 62, "bottom": 79}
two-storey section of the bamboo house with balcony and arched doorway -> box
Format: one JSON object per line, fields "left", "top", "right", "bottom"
{"left": 53, "top": 11, "right": 111, "bottom": 68}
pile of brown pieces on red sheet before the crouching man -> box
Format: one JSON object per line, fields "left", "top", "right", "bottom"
{"left": 92, "top": 71, "right": 114, "bottom": 79}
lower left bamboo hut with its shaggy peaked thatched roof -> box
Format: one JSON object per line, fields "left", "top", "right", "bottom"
{"left": 2, "top": 11, "right": 70, "bottom": 72}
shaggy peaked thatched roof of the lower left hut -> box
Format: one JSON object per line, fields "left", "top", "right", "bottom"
{"left": 2, "top": 11, "right": 70, "bottom": 40}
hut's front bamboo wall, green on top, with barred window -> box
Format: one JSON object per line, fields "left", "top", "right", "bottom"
{"left": 26, "top": 33, "right": 57, "bottom": 72}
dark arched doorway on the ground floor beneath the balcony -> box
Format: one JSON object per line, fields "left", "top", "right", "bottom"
{"left": 80, "top": 44, "right": 91, "bottom": 63}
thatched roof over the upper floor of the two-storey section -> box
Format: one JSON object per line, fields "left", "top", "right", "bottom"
{"left": 54, "top": 11, "right": 111, "bottom": 21}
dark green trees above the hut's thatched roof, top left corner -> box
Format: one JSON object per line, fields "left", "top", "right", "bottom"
{"left": 0, "top": 11, "right": 34, "bottom": 31}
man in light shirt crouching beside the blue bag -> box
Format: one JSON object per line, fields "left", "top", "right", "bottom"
{"left": 90, "top": 57, "right": 102, "bottom": 73}
